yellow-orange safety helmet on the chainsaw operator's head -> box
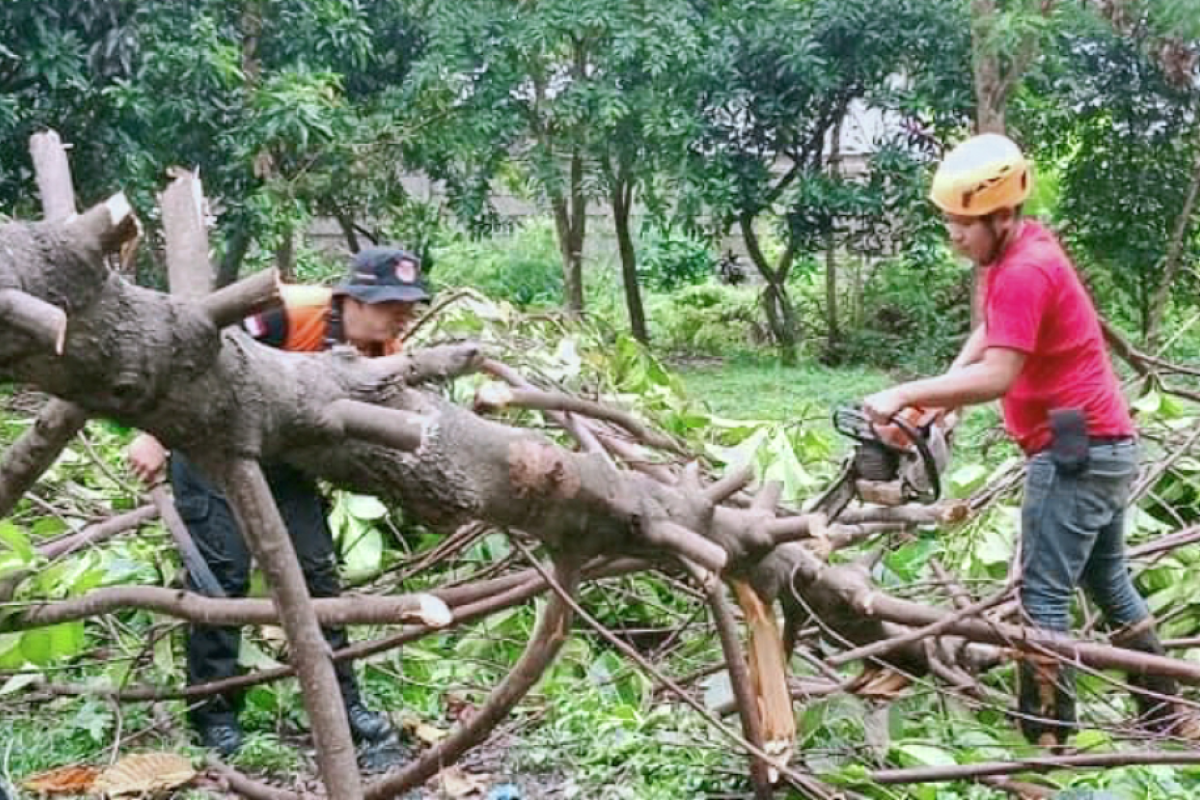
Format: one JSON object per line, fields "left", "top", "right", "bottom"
{"left": 929, "top": 133, "right": 1033, "bottom": 217}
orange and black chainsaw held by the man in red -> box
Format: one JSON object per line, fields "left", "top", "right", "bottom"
{"left": 811, "top": 407, "right": 954, "bottom": 522}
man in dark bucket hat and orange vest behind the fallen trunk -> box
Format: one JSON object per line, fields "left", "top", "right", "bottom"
{"left": 128, "top": 247, "right": 430, "bottom": 756}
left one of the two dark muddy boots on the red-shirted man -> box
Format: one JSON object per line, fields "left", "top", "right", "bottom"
{"left": 1016, "top": 654, "right": 1076, "bottom": 750}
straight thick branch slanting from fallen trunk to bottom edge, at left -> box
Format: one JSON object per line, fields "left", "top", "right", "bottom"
{"left": 219, "top": 458, "right": 362, "bottom": 800}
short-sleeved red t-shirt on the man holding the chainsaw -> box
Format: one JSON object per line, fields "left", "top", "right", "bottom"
{"left": 985, "top": 221, "right": 1134, "bottom": 456}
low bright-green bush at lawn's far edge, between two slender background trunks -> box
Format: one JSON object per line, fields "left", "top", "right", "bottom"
{"left": 647, "top": 282, "right": 767, "bottom": 355}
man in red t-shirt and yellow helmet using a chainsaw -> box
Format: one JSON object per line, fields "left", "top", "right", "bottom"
{"left": 864, "top": 134, "right": 1200, "bottom": 746}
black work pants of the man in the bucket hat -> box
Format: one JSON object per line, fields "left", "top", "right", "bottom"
{"left": 170, "top": 455, "right": 359, "bottom": 727}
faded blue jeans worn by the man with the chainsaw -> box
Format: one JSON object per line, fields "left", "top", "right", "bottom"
{"left": 1021, "top": 441, "right": 1148, "bottom": 632}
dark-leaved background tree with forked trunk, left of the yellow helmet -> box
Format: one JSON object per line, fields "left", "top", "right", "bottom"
{"left": 691, "top": 0, "right": 961, "bottom": 363}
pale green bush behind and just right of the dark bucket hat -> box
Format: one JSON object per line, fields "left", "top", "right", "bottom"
{"left": 433, "top": 218, "right": 563, "bottom": 308}
